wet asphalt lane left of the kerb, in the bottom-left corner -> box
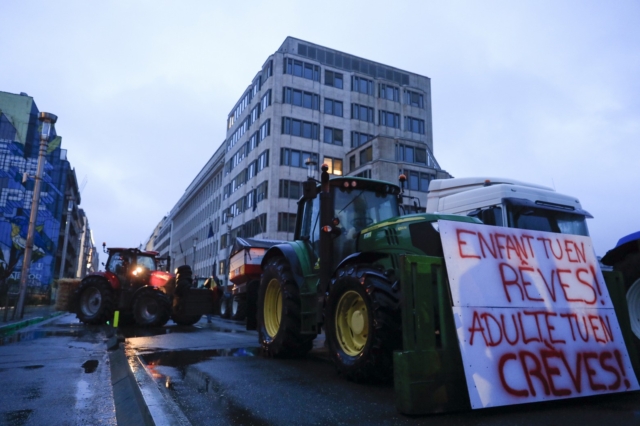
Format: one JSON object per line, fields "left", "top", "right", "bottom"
{"left": 0, "top": 314, "right": 116, "bottom": 426}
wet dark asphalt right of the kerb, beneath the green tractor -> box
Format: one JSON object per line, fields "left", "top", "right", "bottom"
{"left": 124, "top": 318, "right": 640, "bottom": 426}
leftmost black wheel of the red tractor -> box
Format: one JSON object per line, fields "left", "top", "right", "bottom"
{"left": 76, "top": 277, "right": 115, "bottom": 324}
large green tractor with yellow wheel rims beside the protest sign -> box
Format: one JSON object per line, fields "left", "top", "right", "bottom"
{"left": 255, "top": 165, "right": 480, "bottom": 381}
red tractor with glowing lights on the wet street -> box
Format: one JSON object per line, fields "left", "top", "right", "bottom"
{"left": 75, "top": 244, "right": 216, "bottom": 327}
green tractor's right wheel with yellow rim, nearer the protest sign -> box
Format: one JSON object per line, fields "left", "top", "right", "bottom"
{"left": 325, "top": 265, "right": 402, "bottom": 382}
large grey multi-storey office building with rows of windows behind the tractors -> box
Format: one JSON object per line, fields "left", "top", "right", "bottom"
{"left": 154, "top": 37, "right": 449, "bottom": 279}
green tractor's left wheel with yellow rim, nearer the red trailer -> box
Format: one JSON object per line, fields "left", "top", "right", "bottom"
{"left": 257, "top": 257, "right": 316, "bottom": 357}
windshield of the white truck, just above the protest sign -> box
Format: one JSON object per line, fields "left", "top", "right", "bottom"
{"left": 507, "top": 206, "right": 589, "bottom": 236}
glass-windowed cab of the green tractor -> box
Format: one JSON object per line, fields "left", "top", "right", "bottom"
{"left": 295, "top": 177, "right": 400, "bottom": 270}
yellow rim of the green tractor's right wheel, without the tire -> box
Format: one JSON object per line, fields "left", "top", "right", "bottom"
{"left": 335, "top": 290, "right": 369, "bottom": 356}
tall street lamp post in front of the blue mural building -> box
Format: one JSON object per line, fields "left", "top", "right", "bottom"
{"left": 17, "top": 112, "right": 58, "bottom": 318}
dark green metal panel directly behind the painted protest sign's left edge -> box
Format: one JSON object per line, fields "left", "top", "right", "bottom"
{"left": 393, "top": 255, "right": 471, "bottom": 415}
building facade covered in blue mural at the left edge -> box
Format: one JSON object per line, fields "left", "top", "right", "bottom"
{"left": 0, "top": 92, "right": 95, "bottom": 302}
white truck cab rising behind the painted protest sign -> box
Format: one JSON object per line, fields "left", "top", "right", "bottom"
{"left": 426, "top": 177, "right": 593, "bottom": 236}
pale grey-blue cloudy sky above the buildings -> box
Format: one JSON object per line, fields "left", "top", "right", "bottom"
{"left": 0, "top": 0, "right": 640, "bottom": 262}
